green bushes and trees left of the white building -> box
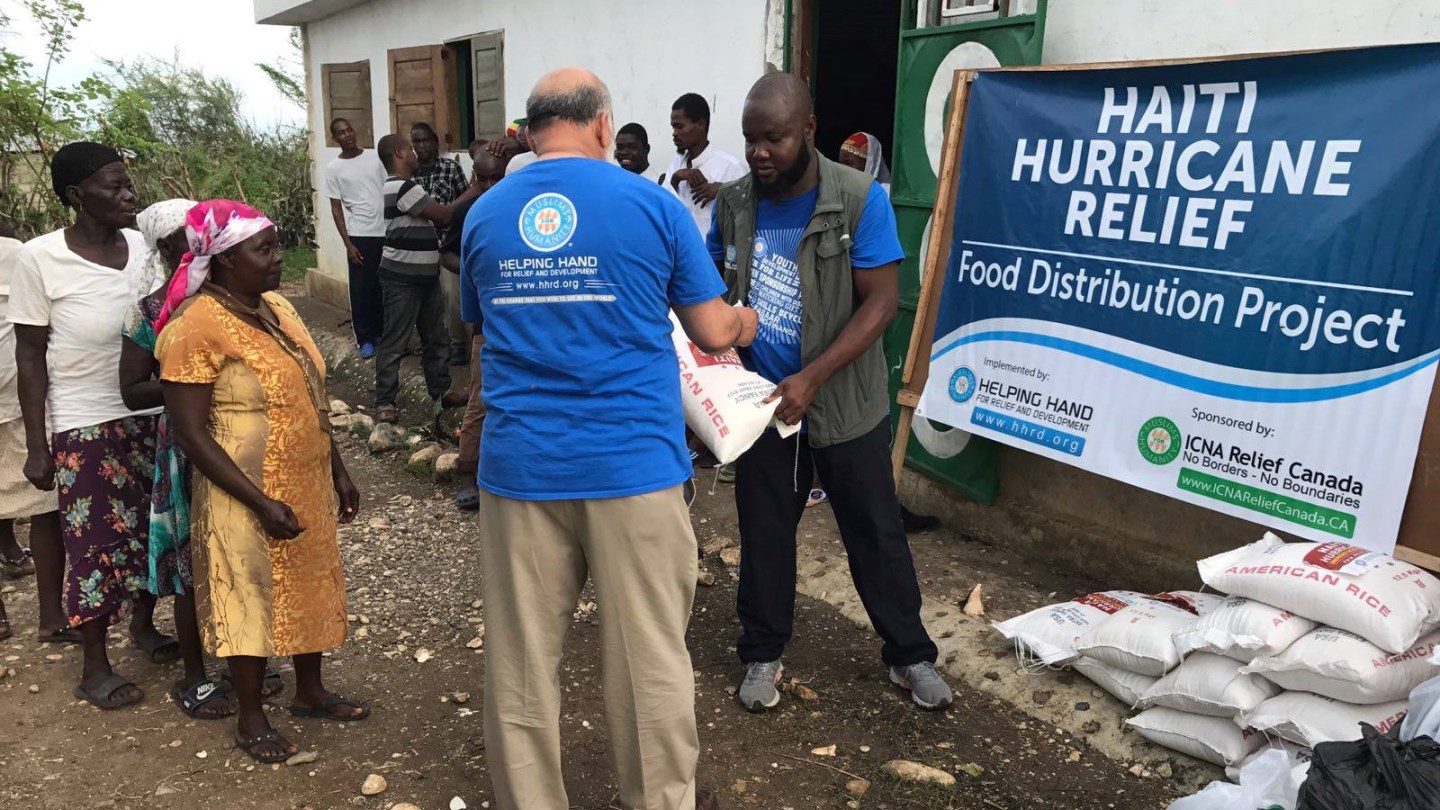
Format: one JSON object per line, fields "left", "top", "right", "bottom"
{"left": 0, "top": 0, "right": 314, "bottom": 246}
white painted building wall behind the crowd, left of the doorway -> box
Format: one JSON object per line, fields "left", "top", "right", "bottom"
{"left": 307, "top": 0, "right": 773, "bottom": 278}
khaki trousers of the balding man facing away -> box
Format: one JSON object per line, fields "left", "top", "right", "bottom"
{"left": 480, "top": 486, "right": 700, "bottom": 810}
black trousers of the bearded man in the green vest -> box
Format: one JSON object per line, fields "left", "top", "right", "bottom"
{"left": 734, "top": 419, "right": 937, "bottom": 666}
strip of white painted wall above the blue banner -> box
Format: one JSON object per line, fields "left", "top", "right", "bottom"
{"left": 1044, "top": 0, "right": 1440, "bottom": 65}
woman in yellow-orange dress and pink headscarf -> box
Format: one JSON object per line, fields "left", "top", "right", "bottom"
{"left": 156, "top": 200, "right": 362, "bottom": 762}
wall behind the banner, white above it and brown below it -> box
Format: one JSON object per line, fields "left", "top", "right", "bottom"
{"left": 904, "top": 0, "right": 1440, "bottom": 591}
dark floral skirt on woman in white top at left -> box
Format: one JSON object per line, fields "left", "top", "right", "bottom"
{"left": 52, "top": 417, "right": 156, "bottom": 627}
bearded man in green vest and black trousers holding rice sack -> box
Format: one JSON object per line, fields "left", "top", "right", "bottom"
{"left": 707, "top": 74, "right": 952, "bottom": 711}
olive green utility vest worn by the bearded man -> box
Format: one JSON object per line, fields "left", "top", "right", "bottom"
{"left": 714, "top": 154, "right": 890, "bottom": 447}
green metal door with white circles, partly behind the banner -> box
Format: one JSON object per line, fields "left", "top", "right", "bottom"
{"left": 886, "top": 0, "right": 1047, "bottom": 503}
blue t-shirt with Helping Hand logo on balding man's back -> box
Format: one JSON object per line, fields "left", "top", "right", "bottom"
{"left": 461, "top": 157, "right": 724, "bottom": 500}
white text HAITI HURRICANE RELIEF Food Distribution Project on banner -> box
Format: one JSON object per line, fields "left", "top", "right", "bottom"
{"left": 956, "top": 81, "right": 1408, "bottom": 355}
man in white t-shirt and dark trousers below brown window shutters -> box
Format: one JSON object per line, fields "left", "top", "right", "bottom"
{"left": 325, "top": 118, "right": 386, "bottom": 359}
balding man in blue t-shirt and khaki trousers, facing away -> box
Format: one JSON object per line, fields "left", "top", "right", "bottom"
{"left": 461, "top": 68, "right": 757, "bottom": 810}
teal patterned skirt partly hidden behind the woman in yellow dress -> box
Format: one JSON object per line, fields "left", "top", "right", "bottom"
{"left": 150, "top": 414, "right": 194, "bottom": 597}
